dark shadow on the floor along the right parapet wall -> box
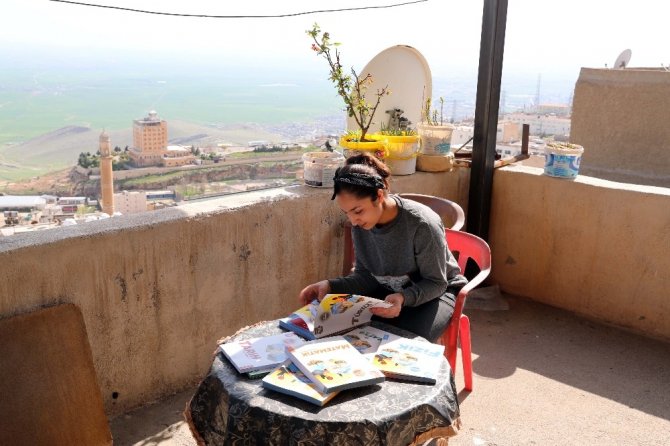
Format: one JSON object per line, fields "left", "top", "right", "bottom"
{"left": 468, "top": 295, "right": 670, "bottom": 420}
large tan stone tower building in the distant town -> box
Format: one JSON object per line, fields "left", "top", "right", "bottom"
{"left": 128, "top": 110, "right": 195, "bottom": 167}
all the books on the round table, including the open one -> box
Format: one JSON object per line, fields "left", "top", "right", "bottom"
{"left": 220, "top": 295, "right": 444, "bottom": 406}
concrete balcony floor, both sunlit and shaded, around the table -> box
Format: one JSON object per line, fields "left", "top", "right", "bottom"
{"left": 111, "top": 296, "right": 670, "bottom": 446}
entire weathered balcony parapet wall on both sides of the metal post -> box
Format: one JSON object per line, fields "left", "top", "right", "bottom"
{"left": 0, "top": 167, "right": 670, "bottom": 416}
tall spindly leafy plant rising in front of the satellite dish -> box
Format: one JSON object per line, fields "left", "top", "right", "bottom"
{"left": 306, "top": 23, "right": 390, "bottom": 141}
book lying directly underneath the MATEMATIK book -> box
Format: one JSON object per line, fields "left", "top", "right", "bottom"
{"left": 261, "top": 360, "right": 338, "bottom": 406}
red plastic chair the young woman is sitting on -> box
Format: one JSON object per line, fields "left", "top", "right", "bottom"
{"left": 440, "top": 229, "right": 491, "bottom": 391}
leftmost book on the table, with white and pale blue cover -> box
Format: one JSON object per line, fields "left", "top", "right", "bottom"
{"left": 219, "top": 332, "right": 305, "bottom": 373}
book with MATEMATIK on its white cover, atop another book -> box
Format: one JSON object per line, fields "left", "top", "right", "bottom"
{"left": 288, "top": 336, "right": 384, "bottom": 393}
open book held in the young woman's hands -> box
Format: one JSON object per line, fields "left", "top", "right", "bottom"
{"left": 279, "top": 294, "right": 392, "bottom": 339}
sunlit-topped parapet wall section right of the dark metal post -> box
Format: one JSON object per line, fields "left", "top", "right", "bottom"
{"left": 490, "top": 166, "right": 670, "bottom": 340}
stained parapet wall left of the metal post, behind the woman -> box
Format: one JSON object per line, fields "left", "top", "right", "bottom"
{"left": 0, "top": 169, "right": 469, "bottom": 416}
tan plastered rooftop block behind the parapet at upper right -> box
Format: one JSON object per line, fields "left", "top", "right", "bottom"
{"left": 570, "top": 68, "right": 670, "bottom": 187}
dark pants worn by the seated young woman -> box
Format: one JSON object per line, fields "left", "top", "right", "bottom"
{"left": 369, "top": 286, "right": 458, "bottom": 342}
